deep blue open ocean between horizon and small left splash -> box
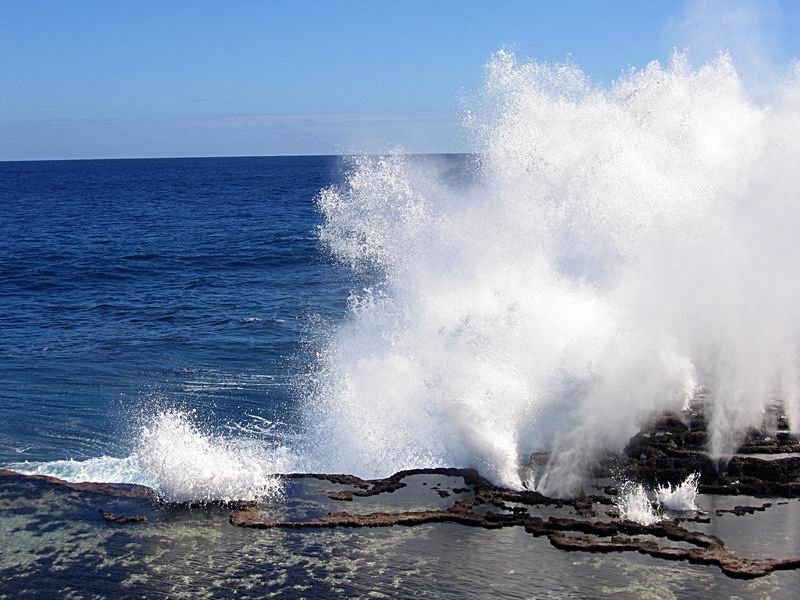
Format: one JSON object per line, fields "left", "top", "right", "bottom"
{"left": 0, "top": 157, "right": 351, "bottom": 464}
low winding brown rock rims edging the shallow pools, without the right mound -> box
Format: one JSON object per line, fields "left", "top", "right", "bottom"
{"left": 3, "top": 469, "right": 800, "bottom": 579}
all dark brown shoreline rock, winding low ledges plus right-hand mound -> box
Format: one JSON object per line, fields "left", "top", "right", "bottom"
{"left": 0, "top": 413, "right": 800, "bottom": 579}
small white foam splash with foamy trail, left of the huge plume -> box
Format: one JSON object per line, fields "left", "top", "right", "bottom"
{"left": 9, "top": 410, "right": 289, "bottom": 504}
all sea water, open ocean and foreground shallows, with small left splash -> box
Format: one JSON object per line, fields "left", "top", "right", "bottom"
{"left": 0, "top": 156, "right": 798, "bottom": 598}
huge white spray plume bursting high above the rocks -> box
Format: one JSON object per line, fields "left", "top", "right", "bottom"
{"left": 306, "top": 52, "right": 800, "bottom": 494}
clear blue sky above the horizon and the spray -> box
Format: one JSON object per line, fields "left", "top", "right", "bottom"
{"left": 0, "top": 0, "right": 800, "bottom": 160}
